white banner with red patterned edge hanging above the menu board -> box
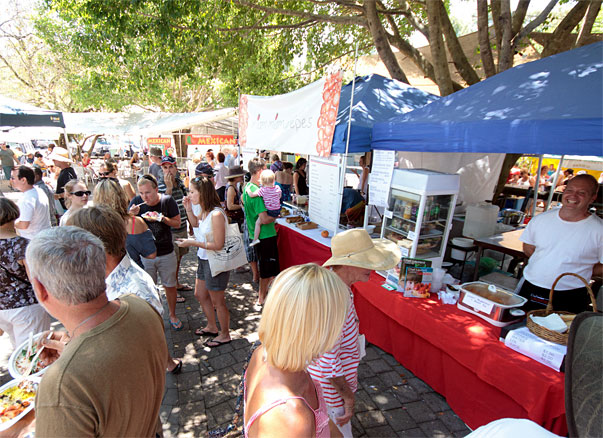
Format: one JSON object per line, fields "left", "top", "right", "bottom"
{"left": 239, "top": 72, "right": 341, "bottom": 157}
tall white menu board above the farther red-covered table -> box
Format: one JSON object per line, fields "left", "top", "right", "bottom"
{"left": 308, "top": 155, "right": 341, "bottom": 232}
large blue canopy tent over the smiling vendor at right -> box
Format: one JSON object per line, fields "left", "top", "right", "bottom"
{"left": 371, "top": 42, "right": 603, "bottom": 155}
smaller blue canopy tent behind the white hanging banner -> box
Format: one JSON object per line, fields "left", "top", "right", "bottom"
{"left": 331, "top": 74, "right": 438, "bottom": 154}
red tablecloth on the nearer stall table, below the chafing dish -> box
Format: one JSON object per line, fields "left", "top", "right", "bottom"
{"left": 353, "top": 274, "right": 567, "bottom": 435}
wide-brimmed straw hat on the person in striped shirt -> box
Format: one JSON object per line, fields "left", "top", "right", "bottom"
{"left": 323, "top": 228, "right": 401, "bottom": 271}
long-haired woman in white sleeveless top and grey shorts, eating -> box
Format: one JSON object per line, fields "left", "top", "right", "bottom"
{"left": 176, "top": 176, "right": 230, "bottom": 348}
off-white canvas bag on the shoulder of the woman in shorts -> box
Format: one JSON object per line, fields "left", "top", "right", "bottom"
{"left": 206, "top": 210, "right": 247, "bottom": 277}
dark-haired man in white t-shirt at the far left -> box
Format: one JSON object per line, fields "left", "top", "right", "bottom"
{"left": 10, "top": 166, "right": 51, "bottom": 239}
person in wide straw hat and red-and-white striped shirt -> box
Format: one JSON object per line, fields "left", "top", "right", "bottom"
{"left": 308, "top": 228, "right": 400, "bottom": 437}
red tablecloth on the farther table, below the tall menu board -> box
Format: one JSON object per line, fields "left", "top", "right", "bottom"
{"left": 276, "top": 224, "right": 331, "bottom": 271}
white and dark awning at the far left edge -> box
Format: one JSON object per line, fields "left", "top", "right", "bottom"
{"left": 0, "top": 96, "right": 65, "bottom": 129}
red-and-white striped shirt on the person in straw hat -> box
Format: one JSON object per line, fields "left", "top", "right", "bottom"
{"left": 308, "top": 291, "right": 360, "bottom": 408}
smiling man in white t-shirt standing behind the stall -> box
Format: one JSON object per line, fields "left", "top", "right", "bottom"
{"left": 519, "top": 175, "right": 603, "bottom": 313}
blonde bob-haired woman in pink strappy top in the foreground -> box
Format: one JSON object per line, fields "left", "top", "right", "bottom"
{"left": 244, "top": 263, "right": 349, "bottom": 437}
